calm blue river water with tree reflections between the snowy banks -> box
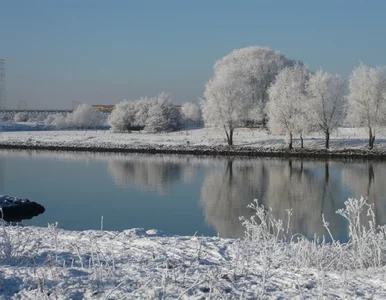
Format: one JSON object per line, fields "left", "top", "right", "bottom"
{"left": 0, "top": 150, "right": 386, "bottom": 240}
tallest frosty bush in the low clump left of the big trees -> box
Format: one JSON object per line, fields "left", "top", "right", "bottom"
{"left": 145, "top": 93, "right": 180, "bottom": 132}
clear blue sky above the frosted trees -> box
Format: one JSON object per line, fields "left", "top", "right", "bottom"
{"left": 0, "top": 0, "right": 386, "bottom": 108}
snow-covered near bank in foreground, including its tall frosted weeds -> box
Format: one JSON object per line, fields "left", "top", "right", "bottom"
{"left": 0, "top": 201, "right": 386, "bottom": 299}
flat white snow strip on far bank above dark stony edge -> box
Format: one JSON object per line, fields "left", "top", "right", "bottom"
{"left": 0, "top": 128, "right": 386, "bottom": 154}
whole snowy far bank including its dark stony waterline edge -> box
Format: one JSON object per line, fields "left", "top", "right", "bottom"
{"left": 0, "top": 128, "right": 386, "bottom": 157}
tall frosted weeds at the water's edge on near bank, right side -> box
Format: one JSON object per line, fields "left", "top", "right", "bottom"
{"left": 241, "top": 197, "right": 386, "bottom": 272}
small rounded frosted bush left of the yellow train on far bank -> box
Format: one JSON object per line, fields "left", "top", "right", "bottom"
{"left": 71, "top": 103, "right": 106, "bottom": 128}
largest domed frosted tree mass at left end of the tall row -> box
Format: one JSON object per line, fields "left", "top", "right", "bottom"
{"left": 201, "top": 47, "right": 293, "bottom": 145}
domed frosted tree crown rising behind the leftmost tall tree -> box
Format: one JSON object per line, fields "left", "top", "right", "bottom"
{"left": 214, "top": 46, "right": 294, "bottom": 124}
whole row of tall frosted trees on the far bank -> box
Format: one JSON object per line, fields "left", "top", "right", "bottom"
{"left": 200, "top": 47, "right": 386, "bottom": 149}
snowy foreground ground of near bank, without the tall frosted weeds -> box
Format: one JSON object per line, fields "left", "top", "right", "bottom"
{"left": 0, "top": 227, "right": 386, "bottom": 299}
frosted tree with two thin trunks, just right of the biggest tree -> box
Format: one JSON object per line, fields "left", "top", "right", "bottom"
{"left": 267, "top": 65, "right": 308, "bottom": 150}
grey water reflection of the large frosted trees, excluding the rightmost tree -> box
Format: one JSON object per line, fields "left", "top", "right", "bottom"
{"left": 201, "top": 160, "right": 344, "bottom": 237}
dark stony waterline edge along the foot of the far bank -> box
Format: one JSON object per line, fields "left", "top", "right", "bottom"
{"left": 0, "top": 141, "right": 386, "bottom": 160}
